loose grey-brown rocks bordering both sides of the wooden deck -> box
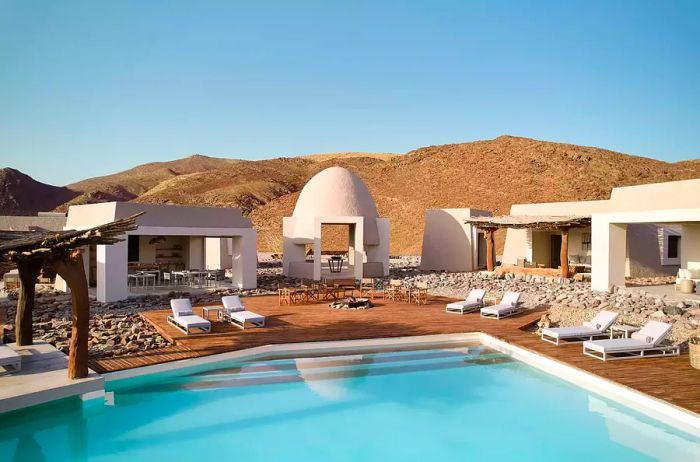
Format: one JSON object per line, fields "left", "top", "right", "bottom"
{"left": 0, "top": 262, "right": 700, "bottom": 357}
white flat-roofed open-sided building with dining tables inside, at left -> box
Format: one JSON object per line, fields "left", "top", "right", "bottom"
{"left": 56, "top": 202, "right": 257, "bottom": 302}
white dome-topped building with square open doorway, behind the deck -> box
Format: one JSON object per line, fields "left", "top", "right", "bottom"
{"left": 283, "top": 167, "right": 389, "bottom": 280}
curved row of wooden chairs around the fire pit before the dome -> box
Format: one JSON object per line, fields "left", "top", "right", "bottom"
{"left": 278, "top": 278, "right": 429, "bottom": 306}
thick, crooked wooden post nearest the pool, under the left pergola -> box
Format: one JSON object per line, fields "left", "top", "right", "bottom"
{"left": 51, "top": 253, "right": 90, "bottom": 379}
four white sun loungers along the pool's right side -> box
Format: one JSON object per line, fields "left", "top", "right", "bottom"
{"left": 445, "top": 289, "right": 680, "bottom": 361}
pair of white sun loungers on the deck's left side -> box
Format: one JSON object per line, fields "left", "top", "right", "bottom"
{"left": 168, "top": 295, "right": 265, "bottom": 335}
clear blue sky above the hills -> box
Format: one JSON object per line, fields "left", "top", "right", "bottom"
{"left": 0, "top": 0, "right": 700, "bottom": 184}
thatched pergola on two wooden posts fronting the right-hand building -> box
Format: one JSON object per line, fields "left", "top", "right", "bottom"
{"left": 464, "top": 215, "right": 591, "bottom": 277}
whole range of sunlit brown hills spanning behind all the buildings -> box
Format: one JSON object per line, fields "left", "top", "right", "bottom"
{"left": 0, "top": 136, "right": 700, "bottom": 254}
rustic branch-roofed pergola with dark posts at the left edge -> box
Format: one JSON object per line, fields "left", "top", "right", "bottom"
{"left": 0, "top": 214, "right": 141, "bottom": 379}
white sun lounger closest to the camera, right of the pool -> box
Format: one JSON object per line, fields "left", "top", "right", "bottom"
{"left": 583, "top": 321, "right": 680, "bottom": 361}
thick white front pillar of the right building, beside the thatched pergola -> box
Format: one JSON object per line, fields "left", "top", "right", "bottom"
{"left": 591, "top": 214, "right": 627, "bottom": 291}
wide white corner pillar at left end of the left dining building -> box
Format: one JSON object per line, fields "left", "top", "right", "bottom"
{"left": 97, "top": 241, "right": 129, "bottom": 302}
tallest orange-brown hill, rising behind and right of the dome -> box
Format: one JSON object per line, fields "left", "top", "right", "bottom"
{"left": 252, "top": 136, "right": 700, "bottom": 254}
